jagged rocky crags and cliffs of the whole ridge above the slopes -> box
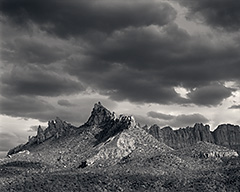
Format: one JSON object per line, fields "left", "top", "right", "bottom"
{"left": 8, "top": 102, "right": 240, "bottom": 155}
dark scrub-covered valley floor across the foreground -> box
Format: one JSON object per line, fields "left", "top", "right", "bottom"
{"left": 0, "top": 158, "right": 240, "bottom": 192}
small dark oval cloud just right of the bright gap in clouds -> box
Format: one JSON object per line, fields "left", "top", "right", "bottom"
{"left": 188, "top": 84, "right": 233, "bottom": 105}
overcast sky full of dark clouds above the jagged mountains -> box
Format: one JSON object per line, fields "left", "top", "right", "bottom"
{"left": 0, "top": 0, "right": 240, "bottom": 156}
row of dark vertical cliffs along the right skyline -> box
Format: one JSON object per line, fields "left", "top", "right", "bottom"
{"left": 148, "top": 123, "right": 240, "bottom": 152}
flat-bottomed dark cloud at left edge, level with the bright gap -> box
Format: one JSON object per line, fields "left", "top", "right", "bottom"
{"left": 1, "top": 66, "right": 84, "bottom": 96}
